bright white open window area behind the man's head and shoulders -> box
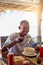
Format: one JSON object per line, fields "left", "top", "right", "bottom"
{"left": 0, "top": 10, "right": 37, "bottom": 37}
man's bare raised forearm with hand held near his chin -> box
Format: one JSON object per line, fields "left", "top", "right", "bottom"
{"left": 1, "top": 36, "right": 24, "bottom": 52}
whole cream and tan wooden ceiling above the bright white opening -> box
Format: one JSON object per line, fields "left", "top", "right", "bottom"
{"left": 0, "top": 0, "right": 43, "bottom": 11}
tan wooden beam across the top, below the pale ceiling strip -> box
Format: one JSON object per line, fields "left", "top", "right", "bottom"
{"left": 0, "top": 2, "right": 43, "bottom": 12}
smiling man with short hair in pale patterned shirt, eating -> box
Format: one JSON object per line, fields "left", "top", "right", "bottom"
{"left": 1, "top": 20, "right": 40, "bottom": 54}
